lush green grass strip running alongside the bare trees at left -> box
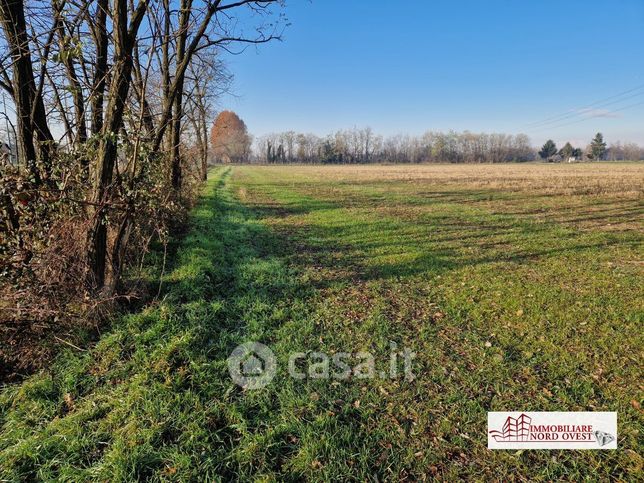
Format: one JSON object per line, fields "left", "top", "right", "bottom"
{"left": 0, "top": 171, "right": 308, "bottom": 481}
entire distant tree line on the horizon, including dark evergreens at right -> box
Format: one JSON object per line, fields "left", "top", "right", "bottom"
{"left": 244, "top": 126, "right": 644, "bottom": 164}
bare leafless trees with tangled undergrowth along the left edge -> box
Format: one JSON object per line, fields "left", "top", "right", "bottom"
{"left": 0, "top": 0, "right": 285, "bottom": 318}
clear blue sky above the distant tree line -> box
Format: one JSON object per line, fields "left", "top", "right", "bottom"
{"left": 221, "top": 0, "right": 644, "bottom": 145}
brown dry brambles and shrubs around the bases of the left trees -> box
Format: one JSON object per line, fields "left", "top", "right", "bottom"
{"left": 0, "top": 147, "right": 197, "bottom": 383}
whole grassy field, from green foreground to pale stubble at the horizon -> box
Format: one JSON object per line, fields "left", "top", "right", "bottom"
{"left": 0, "top": 163, "right": 644, "bottom": 481}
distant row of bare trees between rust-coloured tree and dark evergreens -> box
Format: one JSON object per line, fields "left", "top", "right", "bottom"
{"left": 253, "top": 128, "right": 536, "bottom": 164}
